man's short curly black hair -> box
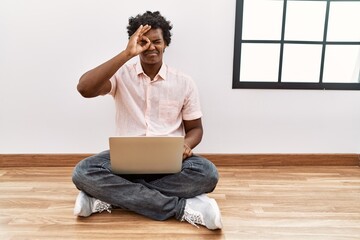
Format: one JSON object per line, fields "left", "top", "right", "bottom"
{"left": 127, "top": 11, "right": 172, "bottom": 46}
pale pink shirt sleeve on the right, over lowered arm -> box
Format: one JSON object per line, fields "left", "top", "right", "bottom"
{"left": 182, "top": 78, "right": 202, "bottom": 121}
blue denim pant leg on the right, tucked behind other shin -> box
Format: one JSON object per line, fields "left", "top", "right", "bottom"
{"left": 136, "top": 155, "right": 219, "bottom": 198}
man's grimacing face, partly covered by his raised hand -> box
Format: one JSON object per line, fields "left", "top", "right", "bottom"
{"left": 140, "top": 28, "right": 166, "bottom": 64}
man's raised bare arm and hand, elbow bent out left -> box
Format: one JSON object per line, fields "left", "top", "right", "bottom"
{"left": 77, "top": 25, "right": 151, "bottom": 98}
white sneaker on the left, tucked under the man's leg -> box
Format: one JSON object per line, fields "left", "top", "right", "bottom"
{"left": 74, "top": 191, "right": 111, "bottom": 217}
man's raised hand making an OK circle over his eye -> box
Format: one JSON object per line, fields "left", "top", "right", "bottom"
{"left": 125, "top": 25, "right": 151, "bottom": 57}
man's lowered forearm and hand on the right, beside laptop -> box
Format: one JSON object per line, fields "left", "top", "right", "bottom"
{"left": 183, "top": 118, "right": 203, "bottom": 159}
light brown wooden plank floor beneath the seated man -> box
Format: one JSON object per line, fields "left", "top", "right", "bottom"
{"left": 0, "top": 166, "right": 360, "bottom": 240}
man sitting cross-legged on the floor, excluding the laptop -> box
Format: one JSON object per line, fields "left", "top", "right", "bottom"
{"left": 73, "top": 11, "right": 222, "bottom": 229}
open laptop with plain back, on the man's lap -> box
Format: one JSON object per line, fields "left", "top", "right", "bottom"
{"left": 109, "top": 136, "right": 184, "bottom": 174}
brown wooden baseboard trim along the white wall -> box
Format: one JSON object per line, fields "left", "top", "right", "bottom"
{"left": 0, "top": 153, "right": 360, "bottom": 167}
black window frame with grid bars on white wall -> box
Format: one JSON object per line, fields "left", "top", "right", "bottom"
{"left": 232, "top": 0, "right": 360, "bottom": 90}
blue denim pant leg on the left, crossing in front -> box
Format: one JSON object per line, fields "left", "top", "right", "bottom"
{"left": 72, "top": 151, "right": 185, "bottom": 220}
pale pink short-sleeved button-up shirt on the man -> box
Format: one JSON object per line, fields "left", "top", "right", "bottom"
{"left": 109, "top": 63, "right": 202, "bottom": 136}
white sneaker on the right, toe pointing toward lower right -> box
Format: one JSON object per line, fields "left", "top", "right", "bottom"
{"left": 181, "top": 194, "right": 222, "bottom": 230}
